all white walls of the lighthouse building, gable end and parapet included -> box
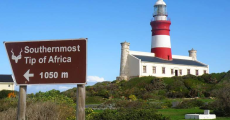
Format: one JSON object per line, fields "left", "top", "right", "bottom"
{"left": 128, "top": 51, "right": 209, "bottom": 77}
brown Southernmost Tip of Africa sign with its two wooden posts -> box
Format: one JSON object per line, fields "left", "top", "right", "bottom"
{"left": 4, "top": 38, "right": 87, "bottom": 120}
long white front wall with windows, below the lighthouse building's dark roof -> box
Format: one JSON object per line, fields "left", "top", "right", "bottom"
{"left": 140, "top": 62, "right": 209, "bottom": 77}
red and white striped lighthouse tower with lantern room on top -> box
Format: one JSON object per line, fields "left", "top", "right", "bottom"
{"left": 150, "top": 0, "right": 172, "bottom": 60}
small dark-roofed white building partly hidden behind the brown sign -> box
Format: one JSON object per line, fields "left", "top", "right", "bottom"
{"left": 0, "top": 75, "right": 14, "bottom": 91}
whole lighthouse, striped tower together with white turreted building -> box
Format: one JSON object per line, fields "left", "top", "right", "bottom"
{"left": 117, "top": 0, "right": 209, "bottom": 80}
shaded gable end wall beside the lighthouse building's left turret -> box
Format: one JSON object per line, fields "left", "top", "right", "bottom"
{"left": 128, "top": 55, "right": 141, "bottom": 76}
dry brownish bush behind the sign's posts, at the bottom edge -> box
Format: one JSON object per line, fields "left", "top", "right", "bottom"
{"left": 0, "top": 101, "right": 76, "bottom": 120}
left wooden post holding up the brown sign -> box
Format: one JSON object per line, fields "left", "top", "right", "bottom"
{"left": 17, "top": 85, "right": 27, "bottom": 120}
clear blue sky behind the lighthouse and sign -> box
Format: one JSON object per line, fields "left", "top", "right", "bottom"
{"left": 0, "top": 0, "right": 230, "bottom": 93}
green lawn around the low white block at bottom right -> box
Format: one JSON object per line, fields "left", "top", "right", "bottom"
{"left": 158, "top": 108, "right": 230, "bottom": 120}
